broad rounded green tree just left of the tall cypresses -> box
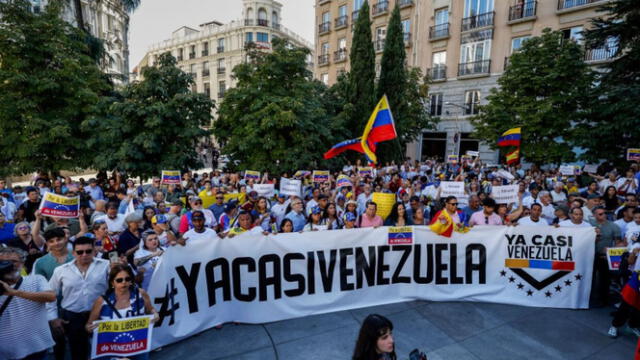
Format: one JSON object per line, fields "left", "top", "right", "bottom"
{"left": 213, "top": 39, "right": 333, "bottom": 173}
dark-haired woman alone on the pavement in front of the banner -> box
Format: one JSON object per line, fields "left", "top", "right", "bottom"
{"left": 351, "top": 314, "right": 397, "bottom": 360}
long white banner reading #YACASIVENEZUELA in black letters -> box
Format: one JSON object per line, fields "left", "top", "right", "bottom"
{"left": 149, "top": 226, "right": 595, "bottom": 347}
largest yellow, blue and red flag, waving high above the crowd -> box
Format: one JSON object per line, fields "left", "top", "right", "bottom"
{"left": 360, "top": 95, "right": 398, "bottom": 164}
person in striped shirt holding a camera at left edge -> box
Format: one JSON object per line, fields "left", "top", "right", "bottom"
{"left": 0, "top": 247, "right": 56, "bottom": 360}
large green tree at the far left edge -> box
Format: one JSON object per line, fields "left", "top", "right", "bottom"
{"left": 0, "top": 0, "right": 112, "bottom": 174}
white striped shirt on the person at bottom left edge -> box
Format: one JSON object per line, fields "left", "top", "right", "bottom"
{"left": 0, "top": 275, "right": 55, "bottom": 359}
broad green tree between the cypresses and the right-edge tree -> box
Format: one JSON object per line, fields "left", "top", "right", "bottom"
{"left": 472, "top": 29, "right": 593, "bottom": 164}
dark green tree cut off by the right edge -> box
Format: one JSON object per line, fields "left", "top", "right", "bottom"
{"left": 576, "top": 0, "right": 640, "bottom": 164}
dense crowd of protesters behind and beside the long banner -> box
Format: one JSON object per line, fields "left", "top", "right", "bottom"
{"left": 0, "top": 160, "right": 640, "bottom": 360}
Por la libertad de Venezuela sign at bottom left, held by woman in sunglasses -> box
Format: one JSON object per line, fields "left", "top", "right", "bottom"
{"left": 91, "top": 316, "right": 153, "bottom": 359}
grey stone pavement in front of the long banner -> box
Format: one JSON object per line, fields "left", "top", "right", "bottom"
{"left": 150, "top": 301, "right": 637, "bottom": 360}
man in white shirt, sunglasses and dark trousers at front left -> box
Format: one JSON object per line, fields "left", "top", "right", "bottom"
{"left": 49, "top": 237, "right": 109, "bottom": 360}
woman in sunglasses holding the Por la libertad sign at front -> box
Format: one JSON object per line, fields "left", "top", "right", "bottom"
{"left": 85, "top": 264, "right": 159, "bottom": 360}
